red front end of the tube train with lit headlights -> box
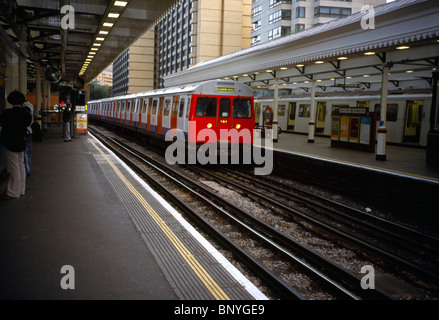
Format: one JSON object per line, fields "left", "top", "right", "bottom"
{"left": 188, "top": 80, "right": 255, "bottom": 163}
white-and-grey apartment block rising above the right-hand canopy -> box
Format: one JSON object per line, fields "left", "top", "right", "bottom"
{"left": 251, "top": 0, "right": 386, "bottom": 45}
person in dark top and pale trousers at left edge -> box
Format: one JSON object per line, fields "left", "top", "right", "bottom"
{"left": 0, "top": 90, "right": 32, "bottom": 199}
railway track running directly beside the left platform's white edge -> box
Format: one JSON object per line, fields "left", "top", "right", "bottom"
{"left": 89, "top": 127, "right": 392, "bottom": 299}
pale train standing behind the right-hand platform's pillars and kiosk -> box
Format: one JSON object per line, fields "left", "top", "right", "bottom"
{"left": 255, "top": 90, "right": 432, "bottom": 146}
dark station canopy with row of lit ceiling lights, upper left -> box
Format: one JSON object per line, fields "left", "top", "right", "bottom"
{"left": 0, "top": 0, "right": 177, "bottom": 82}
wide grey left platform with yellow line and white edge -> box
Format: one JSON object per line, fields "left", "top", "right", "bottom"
{"left": 0, "top": 135, "right": 266, "bottom": 300}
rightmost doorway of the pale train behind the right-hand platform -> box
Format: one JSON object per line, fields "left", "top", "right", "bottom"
{"left": 403, "top": 100, "right": 424, "bottom": 143}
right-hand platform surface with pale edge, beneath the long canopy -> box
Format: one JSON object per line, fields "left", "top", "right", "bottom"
{"left": 266, "top": 132, "right": 439, "bottom": 182}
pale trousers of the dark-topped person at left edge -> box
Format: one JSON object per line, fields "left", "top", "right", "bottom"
{"left": 3, "top": 148, "right": 26, "bottom": 198}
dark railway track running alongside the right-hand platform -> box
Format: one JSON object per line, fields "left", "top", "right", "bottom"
{"left": 193, "top": 168, "right": 439, "bottom": 285}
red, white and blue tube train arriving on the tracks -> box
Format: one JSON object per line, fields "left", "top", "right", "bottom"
{"left": 87, "top": 80, "right": 255, "bottom": 143}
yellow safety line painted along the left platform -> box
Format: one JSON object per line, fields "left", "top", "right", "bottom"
{"left": 90, "top": 141, "right": 230, "bottom": 300}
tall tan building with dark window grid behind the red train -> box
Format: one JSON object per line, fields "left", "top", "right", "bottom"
{"left": 113, "top": 0, "right": 252, "bottom": 95}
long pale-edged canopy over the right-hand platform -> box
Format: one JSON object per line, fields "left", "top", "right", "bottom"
{"left": 164, "top": 0, "right": 439, "bottom": 94}
